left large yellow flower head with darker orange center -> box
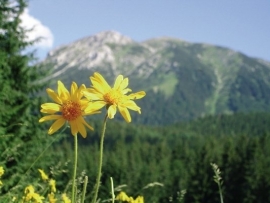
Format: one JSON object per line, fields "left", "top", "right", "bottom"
{"left": 39, "top": 81, "right": 100, "bottom": 138}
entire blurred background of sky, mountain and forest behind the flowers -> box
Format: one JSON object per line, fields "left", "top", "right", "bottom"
{"left": 0, "top": 0, "right": 270, "bottom": 203}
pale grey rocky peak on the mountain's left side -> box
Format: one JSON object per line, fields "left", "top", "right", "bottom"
{"left": 46, "top": 31, "right": 134, "bottom": 76}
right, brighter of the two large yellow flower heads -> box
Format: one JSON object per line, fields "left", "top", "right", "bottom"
{"left": 84, "top": 72, "right": 145, "bottom": 123}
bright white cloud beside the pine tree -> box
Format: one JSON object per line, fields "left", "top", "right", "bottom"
{"left": 21, "top": 9, "right": 53, "bottom": 48}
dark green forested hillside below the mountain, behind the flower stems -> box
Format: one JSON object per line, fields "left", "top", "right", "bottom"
{"left": 42, "top": 113, "right": 270, "bottom": 203}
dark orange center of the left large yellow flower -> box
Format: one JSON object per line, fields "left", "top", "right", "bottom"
{"left": 62, "top": 101, "right": 82, "bottom": 121}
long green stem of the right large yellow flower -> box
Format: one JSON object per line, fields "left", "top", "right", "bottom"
{"left": 92, "top": 114, "right": 108, "bottom": 203}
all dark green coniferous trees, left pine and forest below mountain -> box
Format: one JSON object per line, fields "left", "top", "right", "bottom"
{"left": 0, "top": 0, "right": 270, "bottom": 203}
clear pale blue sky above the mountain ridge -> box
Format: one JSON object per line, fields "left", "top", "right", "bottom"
{"left": 25, "top": 0, "right": 270, "bottom": 61}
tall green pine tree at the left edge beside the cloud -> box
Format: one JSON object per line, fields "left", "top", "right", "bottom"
{"left": 0, "top": 0, "right": 56, "bottom": 197}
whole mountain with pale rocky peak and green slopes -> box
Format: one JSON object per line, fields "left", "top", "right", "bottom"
{"left": 38, "top": 31, "right": 270, "bottom": 125}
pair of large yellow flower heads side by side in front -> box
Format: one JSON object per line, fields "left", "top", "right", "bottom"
{"left": 39, "top": 72, "right": 145, "bottom": 138}
